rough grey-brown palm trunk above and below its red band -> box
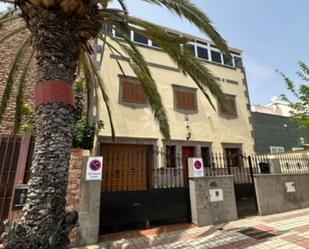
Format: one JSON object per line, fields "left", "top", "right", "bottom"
{"left": 6, "top": 9, "right": 78, "bottom": 249}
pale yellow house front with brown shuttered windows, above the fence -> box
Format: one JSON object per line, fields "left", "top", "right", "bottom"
{"left": 98, "top": 26, "right": 254, "bottom": 176}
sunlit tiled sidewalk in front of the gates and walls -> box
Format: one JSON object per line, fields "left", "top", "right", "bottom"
{"left": 77, "top": 208, "right": 309, "bottom": 249}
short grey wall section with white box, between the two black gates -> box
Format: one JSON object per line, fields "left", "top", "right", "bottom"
{"left": 190, "top": 176, "right": 237, "bottom": 226}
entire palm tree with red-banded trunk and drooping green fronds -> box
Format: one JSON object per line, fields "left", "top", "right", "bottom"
{"left": 0, "top": 0, "right": 229, "bottom": 249}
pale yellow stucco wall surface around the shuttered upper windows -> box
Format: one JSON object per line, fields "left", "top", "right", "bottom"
{"left": 98, "top": 38, "right": 253, "bottom": 153}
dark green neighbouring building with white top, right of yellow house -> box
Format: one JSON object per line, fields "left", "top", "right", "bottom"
{"left": 251, "top": 97, "right": 309, "bottom": 153}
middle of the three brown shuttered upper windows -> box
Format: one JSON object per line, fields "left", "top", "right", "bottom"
{"left": 174, "top": 87, "right": 197, "bottom": 111}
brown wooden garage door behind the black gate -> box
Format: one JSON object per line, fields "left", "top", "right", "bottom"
{"left": 101, "top": 144, "right": 151, "bottom": 192}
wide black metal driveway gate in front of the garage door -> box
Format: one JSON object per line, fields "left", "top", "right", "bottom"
{"left": 100, "top": 144, "right": 191, "bottom": 234}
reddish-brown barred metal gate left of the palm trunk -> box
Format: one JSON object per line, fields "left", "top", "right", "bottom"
{"left": 0, "top": 135, "right": 34, "bottom": 234}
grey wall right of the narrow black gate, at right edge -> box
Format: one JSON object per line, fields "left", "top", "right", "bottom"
{"left": 254, "top": 174, "right": 309, "bottom": 215}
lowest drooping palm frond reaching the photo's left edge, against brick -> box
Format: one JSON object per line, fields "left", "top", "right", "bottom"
{"left": 0, "top": 35, "right": 32, "bottom": 121}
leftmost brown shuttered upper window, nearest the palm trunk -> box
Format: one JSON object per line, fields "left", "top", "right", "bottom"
{"left": 120, "top": 78, "right": 147, "bottom": 105}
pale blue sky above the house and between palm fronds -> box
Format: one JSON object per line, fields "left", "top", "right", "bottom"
{"left": 0, "top": 0, "right": 309, "bottom": 104}
